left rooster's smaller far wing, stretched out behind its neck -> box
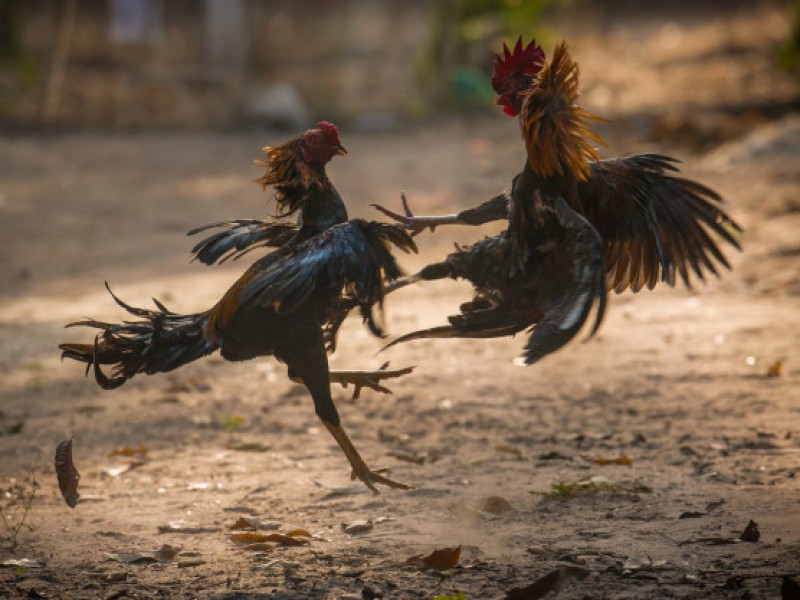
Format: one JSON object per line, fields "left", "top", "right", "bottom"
{"left": 186, "top": 219, "right": 299, "bottom": 265}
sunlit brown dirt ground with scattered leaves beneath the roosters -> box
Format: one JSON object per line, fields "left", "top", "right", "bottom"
{"left": 0, "top": 6, "right": 800, "bottom": 600}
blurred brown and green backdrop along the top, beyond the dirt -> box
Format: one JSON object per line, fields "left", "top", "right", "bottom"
{"left": 0, "top": 0, "right": 800, "bottom": 130}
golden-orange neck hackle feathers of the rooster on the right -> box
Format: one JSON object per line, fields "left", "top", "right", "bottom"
{"left": 520, "top": 42, "right": 604, "bottom": 180}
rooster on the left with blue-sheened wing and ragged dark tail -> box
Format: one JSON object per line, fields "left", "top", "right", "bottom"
{"left": 60, "top": 125, "right": 416, "bottom": 492}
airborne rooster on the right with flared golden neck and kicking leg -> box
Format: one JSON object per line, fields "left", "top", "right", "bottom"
{"left": 376, "top": 38, "right": 741, "bottom": 364}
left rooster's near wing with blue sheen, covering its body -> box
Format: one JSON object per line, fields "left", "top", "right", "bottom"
{"left": 238, "top": 219, "right": 417, "bottom": 333}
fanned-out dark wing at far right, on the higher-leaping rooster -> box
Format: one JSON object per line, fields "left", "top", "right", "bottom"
{"left": 578, "top": 154, "right": 741, "bottom": 293}
